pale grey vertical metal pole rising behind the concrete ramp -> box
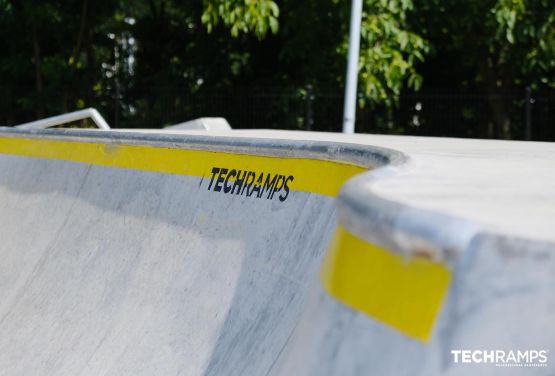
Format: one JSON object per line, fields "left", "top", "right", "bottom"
{"left": 343, "top": 0, "right": 362, "bottom": 133}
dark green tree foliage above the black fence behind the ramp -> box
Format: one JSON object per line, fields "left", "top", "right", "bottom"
{"left": 0, "top": 0, "right": 555, "bottom": 133}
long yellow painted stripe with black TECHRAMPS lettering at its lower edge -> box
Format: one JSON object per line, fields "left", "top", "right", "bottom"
{"left": 0, "top": 137, "right": 367, "bottom": 196}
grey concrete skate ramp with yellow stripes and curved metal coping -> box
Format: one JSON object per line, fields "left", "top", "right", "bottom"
{"left": 0, "top": 128, "right": 555, "bottom": 376}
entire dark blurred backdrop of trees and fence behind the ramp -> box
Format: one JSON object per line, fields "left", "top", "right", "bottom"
{"left": 0, "top": 0, "right": 555, "bottom": 140}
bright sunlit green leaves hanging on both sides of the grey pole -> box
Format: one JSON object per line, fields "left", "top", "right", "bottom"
{"left": 202, "top": 0, "right": 428, "bottom": 106}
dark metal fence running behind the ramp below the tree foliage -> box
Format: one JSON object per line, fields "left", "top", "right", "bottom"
{"left": 0, "top": 86, "right": 555, "bottom": 141}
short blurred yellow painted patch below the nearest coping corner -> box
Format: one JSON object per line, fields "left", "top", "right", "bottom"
{"left": 320, "top": 225, "right": 451, "bottom": 341}
